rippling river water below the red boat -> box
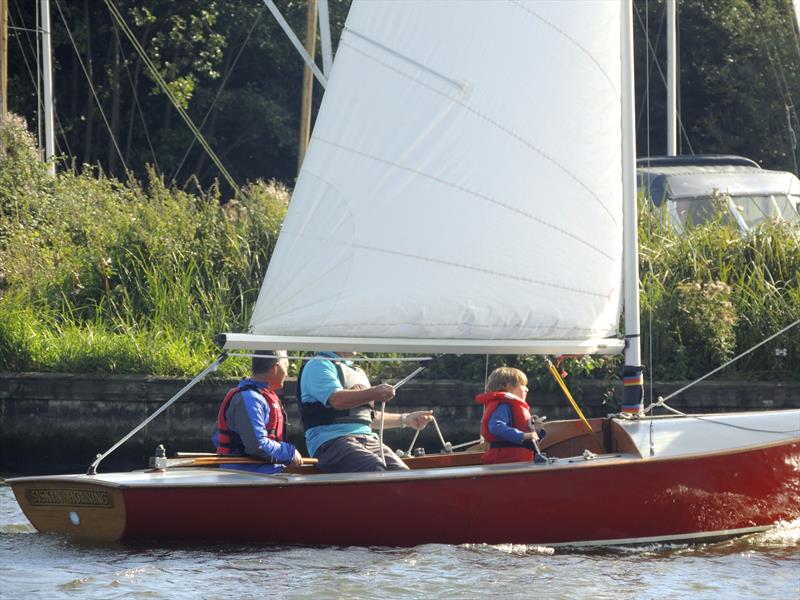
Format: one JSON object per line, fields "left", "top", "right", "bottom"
{"left": 0, "top": 485, "right": 800, "bottom": 600}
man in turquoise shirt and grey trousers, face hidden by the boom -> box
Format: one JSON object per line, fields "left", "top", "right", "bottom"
{"left": 297, "top": 352, "right": 433, "bottom": 473}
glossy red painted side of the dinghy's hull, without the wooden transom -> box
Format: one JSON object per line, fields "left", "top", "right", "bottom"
{"left": 115, "top": 442, "right": 800, "bottom": 546}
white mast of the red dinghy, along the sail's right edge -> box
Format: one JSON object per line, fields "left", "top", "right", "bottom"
{"left": 621, "top": 0, "right": 644, "bottom": 414}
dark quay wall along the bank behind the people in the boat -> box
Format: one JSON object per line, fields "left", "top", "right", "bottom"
{"left": 0, "top": 373, "right": 800, "bottom": 474}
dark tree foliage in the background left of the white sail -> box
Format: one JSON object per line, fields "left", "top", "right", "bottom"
{"left": 9, "top": 0, "right": 349, "bottom": 187}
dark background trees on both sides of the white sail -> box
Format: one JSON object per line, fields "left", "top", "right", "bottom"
{"left": 9, "top": 0, "right": 800, "bottom": 187}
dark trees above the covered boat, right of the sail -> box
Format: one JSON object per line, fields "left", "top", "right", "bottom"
{"left": 636, "top": 0, "right": 800, "bottom": 171}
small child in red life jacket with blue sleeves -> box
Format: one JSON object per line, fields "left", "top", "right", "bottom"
{"left": 475, "top": 367, "right": 544, "bottom": 465}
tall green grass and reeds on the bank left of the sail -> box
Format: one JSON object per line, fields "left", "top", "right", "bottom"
{"left": 0, "top": 119, "right": 289, "bottom": 375}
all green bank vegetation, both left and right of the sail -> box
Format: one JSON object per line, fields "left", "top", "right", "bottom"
{"left": 0, "top": 118, "right": 800, "bottom": 384}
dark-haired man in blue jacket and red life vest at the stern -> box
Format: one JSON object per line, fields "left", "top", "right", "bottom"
{"left": 213, "top": 350, "right": 302, "bottom": 473}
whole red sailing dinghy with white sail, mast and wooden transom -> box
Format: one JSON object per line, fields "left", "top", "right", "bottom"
{"left": 9, "top": 0, "right": 800, "bottom": 546}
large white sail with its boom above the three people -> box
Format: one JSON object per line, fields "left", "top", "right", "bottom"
{"left": 241, "top": 0, "right": 626, "bottom": 353}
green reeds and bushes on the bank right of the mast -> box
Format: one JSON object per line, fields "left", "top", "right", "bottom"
{"left": 639, "top": 204, "right": 800, "bottom": 379}
